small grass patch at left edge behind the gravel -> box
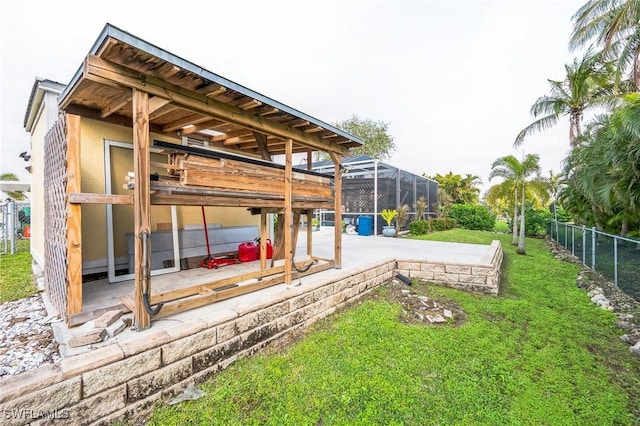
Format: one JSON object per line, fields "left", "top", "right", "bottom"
{"left": 0, "top": 240, "right": 38, "bottom": 303}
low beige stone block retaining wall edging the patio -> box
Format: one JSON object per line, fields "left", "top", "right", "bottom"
{"left": 0, "top": 242, "right": 502, "bottom": 425}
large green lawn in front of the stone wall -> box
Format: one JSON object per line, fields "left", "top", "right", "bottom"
{"left": 149, "top": 229, "right": 640, "bottom": 425}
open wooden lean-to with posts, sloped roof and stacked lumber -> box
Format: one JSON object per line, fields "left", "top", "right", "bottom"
{"left": 60, "top": 24, "right": 362, "bottom": 330}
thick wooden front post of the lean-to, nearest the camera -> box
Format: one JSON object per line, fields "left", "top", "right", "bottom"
{"left": 133, "top": 89, "right": 151, "bottom": 331}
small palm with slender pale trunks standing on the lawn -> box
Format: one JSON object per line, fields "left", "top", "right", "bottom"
{"left": 489, "top": 154, "right": 540, "bottom": 254}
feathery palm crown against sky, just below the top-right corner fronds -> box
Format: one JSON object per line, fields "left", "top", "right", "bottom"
{"left": 513, "top": 52, "right": 616, "bottom": 147}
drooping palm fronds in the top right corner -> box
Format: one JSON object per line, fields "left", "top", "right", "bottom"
{"left": 569, "top": 0, "right": 640, "bottom": 90}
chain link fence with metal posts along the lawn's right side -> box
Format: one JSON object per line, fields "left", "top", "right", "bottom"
{"left": 547, "top": 221, "right": 640, "bottom": 301}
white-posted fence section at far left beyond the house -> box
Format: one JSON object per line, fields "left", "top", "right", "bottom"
{"left": 0, "top": 199, "right": 31, "bottom": 254}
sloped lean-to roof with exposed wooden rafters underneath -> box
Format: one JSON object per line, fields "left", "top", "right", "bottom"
{"left": 60, "top": 24, "right": 363, "bottom": 157}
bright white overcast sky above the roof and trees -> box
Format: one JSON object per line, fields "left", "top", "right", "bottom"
{"left": 0, "top": 0, "right": 583, "bottom": 195}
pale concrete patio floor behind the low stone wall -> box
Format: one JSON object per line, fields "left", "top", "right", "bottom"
{"left": 54, "top": 226, "right": 502, "bottom": 357}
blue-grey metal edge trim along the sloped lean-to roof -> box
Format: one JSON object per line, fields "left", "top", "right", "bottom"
{"left": 58, "top": 23, "right": 364, "bottom": 145}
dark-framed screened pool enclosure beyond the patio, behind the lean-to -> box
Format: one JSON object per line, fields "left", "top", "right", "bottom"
{"left": 312, "top": 155, "right": 438, "bottom": 235}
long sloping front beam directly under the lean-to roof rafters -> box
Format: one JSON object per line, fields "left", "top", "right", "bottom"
{"left": 83, "top": 55, "right": 349, "bottom": 155}
